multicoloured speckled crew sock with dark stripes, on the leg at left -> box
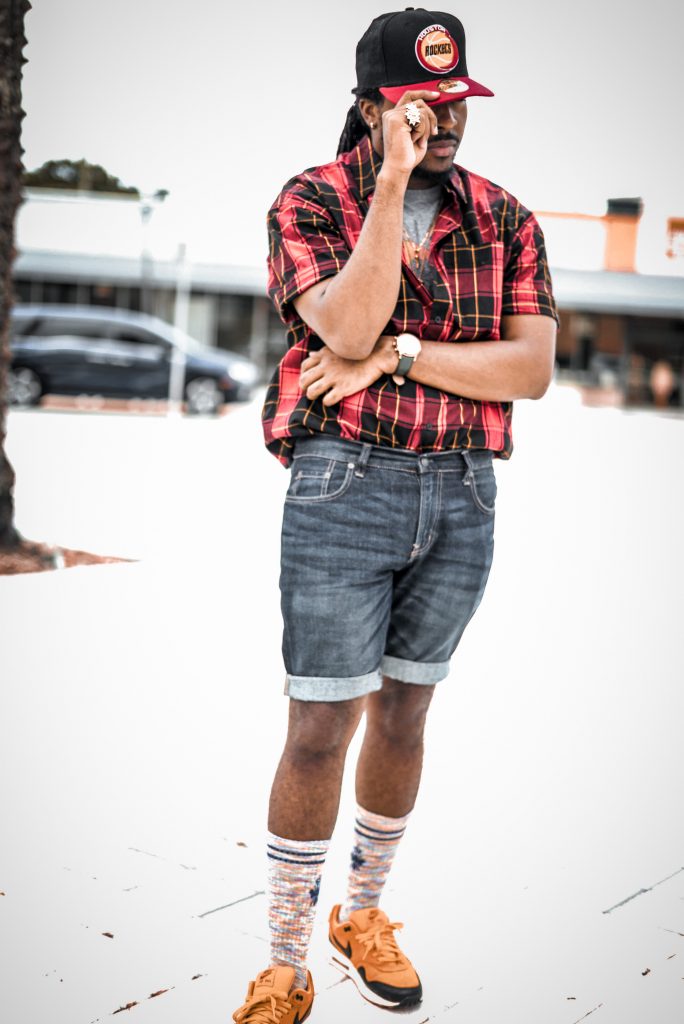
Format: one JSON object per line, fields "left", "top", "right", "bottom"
{"left": 266, "top": 833, "right": 330, "bottom": 988}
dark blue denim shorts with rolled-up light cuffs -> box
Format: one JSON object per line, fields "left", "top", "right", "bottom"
{"left": 281, "top": 436, "right": 497, "bottom": 700}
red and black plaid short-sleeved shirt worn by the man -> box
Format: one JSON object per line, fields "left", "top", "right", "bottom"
{"left": 262, "top": 138, "right": 558, "bottom": 466}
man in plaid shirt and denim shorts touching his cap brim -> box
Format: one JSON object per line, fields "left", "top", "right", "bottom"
{"left": 233, "top": 8, "right": 556, "bottom": 1024}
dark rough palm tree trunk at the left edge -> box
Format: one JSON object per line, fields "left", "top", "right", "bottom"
{"left": 0, "top": 0, "right": 31, "bottom": 548}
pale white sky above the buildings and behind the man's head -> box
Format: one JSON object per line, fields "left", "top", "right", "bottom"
{"left": 15, "top": 0, "right": 684, "bottom": 272}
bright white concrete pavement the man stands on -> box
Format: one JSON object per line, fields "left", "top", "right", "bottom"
{"left": 0, "top": 387, "right": 684, "bottom": 1024}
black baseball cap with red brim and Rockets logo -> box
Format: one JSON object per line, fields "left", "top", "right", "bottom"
{"left": 351, "top": 7, "right": 494, "bottom": 106}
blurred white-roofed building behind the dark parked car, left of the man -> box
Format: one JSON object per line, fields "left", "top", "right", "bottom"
{"left": 13, "top": 188, "right": 284, "bottom": 385}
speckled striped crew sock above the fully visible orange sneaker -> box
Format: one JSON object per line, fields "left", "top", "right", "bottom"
{"left": 340, "top": 805, "right": 411, "bottom": 921}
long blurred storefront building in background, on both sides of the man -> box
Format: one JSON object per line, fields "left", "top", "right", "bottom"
{"left": 14, "top": 190, "right": 684, "bottom": 408}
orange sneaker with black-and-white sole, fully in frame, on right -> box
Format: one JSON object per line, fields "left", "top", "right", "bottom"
{"left": 329, "top": 903, "right": 423, "bottom": 1007}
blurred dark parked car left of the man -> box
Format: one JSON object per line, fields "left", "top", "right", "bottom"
{"left": 8, "top": 304, "right": 257, "bottom": 414}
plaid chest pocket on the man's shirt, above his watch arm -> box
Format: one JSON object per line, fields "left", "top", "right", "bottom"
{"left": 443, "top": 234, "right": 504, "bottom": 339}
